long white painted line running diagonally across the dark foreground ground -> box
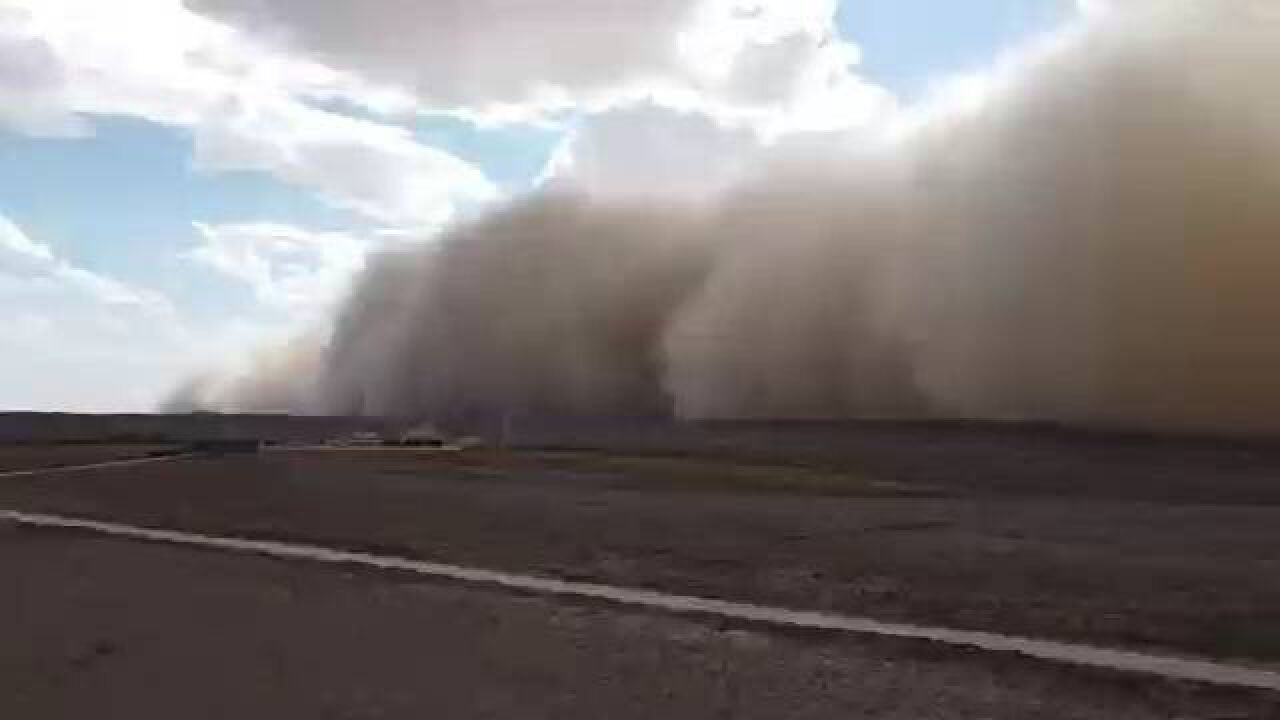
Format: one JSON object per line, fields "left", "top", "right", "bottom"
{"left": 0, "top": 510, "right": 1280, "bottom": 691}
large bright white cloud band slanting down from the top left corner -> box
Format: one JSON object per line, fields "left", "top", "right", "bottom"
{"left": 0, "top": 0, "right": 495, "bottom": 227}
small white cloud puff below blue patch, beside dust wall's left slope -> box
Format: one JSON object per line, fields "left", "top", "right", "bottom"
{"left": 188, "top": 223, "right": 370, "bottom": 311}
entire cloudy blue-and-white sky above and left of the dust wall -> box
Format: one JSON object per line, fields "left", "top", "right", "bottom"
{"left": 0, "top": 0, "right": 1084, "bottom": 411}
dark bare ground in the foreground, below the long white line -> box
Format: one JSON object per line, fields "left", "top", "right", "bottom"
{"left": 0, "top": 524, "right": 1280, "bottom": 720}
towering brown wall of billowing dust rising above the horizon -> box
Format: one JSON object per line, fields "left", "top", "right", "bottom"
{"left": 174, "top": 0, "right": 1280, "bottom": 432}
